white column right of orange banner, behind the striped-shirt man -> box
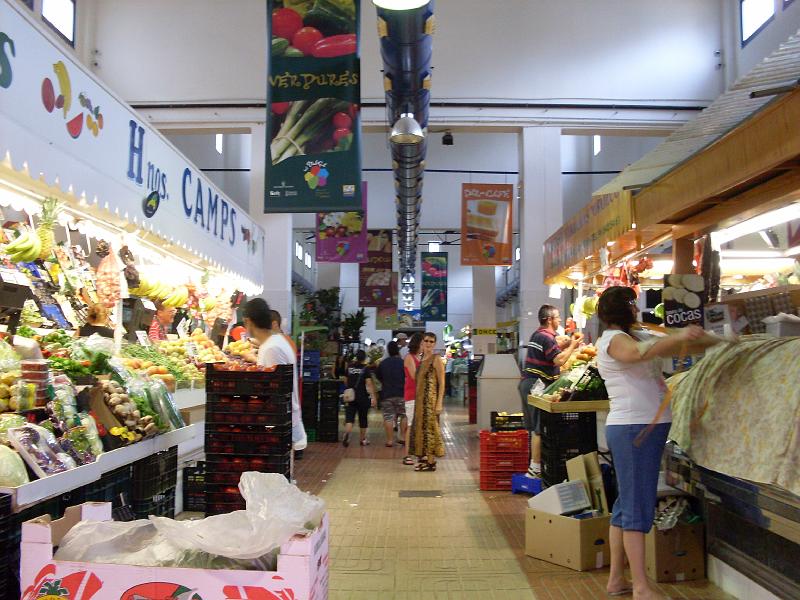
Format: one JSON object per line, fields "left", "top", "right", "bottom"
{"left": 519, "top": 127, "right": 564, "bottom": 344}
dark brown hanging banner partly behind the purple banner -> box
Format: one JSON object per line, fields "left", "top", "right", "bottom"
{"left": 358, "top": 229, "right": 397, "bottom": 308}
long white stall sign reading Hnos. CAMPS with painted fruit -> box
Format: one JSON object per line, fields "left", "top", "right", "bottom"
{"left": 0, "top": 2, "right": 264, "bottom": 285}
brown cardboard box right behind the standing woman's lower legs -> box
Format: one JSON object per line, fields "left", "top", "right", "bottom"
{"left": 645, "top": 523, "right": 705, "bottom": 583}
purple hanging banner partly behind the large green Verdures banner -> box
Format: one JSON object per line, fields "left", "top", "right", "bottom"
{"left": 317, "top": 182, "right": 367, "bottom": 263}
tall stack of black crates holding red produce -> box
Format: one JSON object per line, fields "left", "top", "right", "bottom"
{"left": 204, "top": 364, "right": 293, "bottom": 515}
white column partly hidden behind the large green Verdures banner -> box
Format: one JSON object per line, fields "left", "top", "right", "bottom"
{"left": 250, "top": 124, "right": 294, "bottom": 331}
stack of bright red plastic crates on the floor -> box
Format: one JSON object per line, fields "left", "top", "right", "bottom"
{"left": 480, "top": 429, "right": 529, "bottom": 490}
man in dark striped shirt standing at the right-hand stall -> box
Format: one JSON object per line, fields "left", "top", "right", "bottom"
{"left": 519, "top": 304, "right": 583, "bottom": 478}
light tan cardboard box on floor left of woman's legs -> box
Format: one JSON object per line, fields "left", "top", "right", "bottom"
{"left": 525, "top": 508, "right": 611, "bottom": 571}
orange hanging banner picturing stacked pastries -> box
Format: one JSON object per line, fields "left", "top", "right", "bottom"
{"left": 461, "top": 183, "right": 514, "bottom": 266}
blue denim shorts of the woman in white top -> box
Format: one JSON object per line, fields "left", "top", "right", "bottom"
{"left": 606, "top": 423, "right": 670, "bottom": 533}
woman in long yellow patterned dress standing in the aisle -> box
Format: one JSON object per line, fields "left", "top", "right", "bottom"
{"left": 409, "top": 331, "right": 444, "bottom": 471}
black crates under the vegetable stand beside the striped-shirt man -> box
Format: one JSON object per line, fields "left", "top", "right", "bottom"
{"left": 540, "top": 410, "right": 597, "bottom": 486}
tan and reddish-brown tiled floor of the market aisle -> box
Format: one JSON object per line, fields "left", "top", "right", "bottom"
{"left": 296, "top": 398, "right": 728, "bottom": 600}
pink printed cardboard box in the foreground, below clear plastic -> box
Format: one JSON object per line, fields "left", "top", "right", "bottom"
{"left": 20, "top": 502, "right": 328, "bottom": 600}
